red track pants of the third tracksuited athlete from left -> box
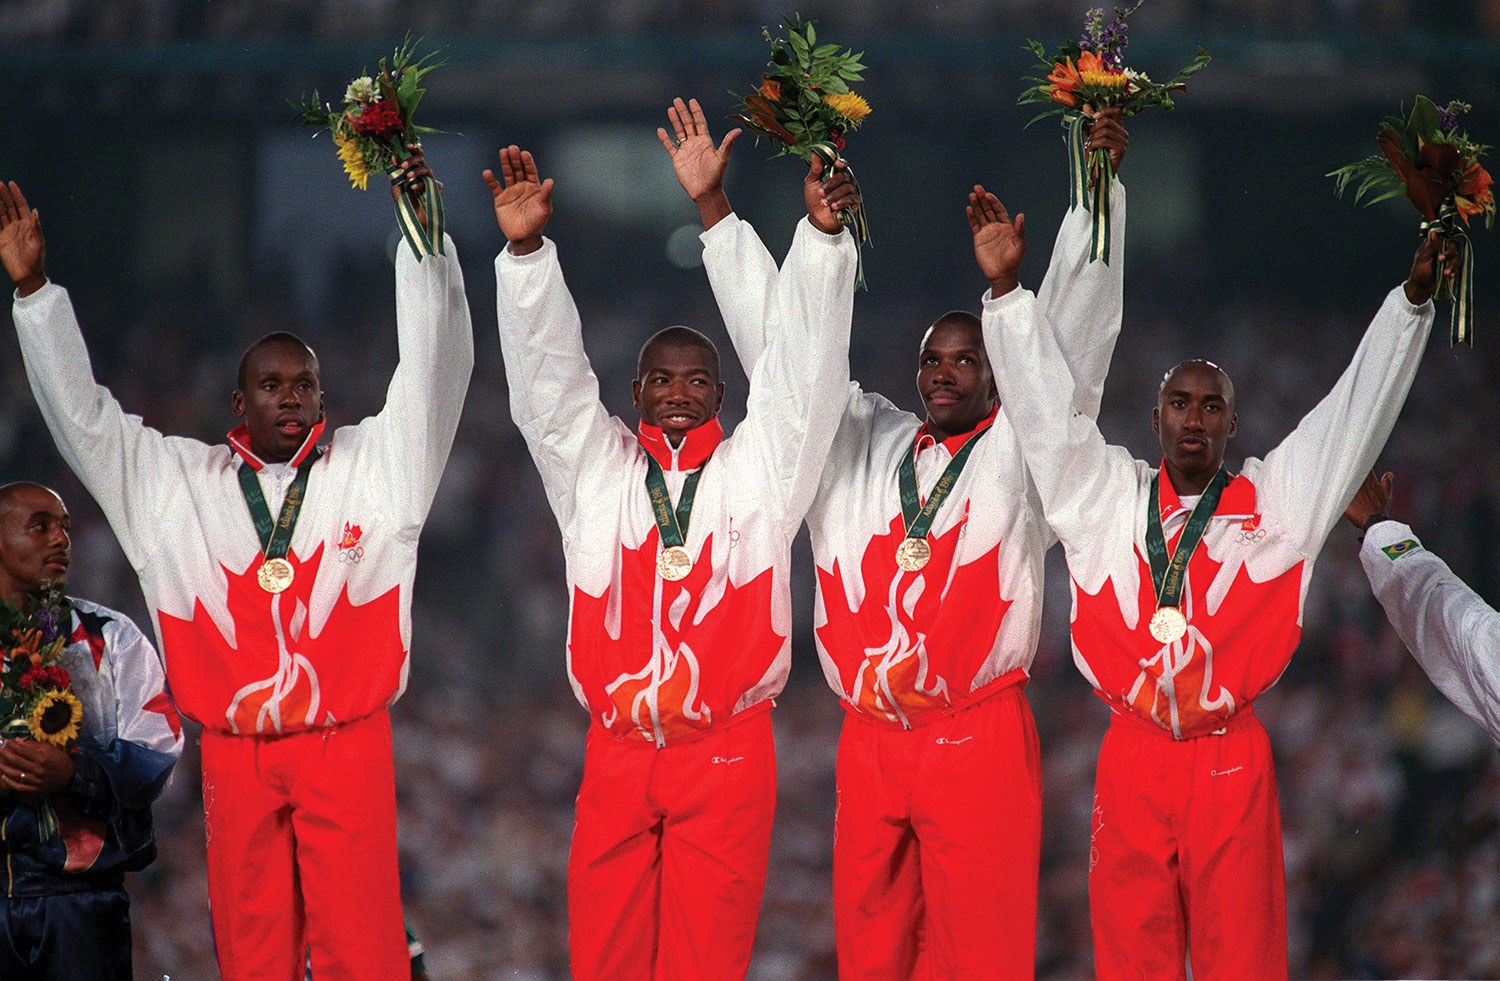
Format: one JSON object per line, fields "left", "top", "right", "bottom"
{"left": 834, "top": 684, "right": 1041, "bottom": 981}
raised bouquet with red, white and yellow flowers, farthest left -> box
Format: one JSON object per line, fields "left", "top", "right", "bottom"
{"left": 291, "top": 38, "right": 444, "bottom": 260}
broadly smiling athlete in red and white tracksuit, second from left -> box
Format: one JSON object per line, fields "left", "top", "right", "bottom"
{"left": 488, "top": 147, "right": 855, "bottom": 980}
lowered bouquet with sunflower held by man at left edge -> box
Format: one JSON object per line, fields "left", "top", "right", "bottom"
{"left": 0, "top": 582, "right": 84, "bottom": 840}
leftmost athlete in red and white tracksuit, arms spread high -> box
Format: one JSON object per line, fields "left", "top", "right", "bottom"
{"left": 5, "top": 165, "right": 474, "bottom": 981}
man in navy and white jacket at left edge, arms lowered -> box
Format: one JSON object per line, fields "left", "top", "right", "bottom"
{"left": 0, "top": 482, "right": 183, "bottom": 981}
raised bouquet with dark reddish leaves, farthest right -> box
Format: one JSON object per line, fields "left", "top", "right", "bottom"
{"left": 1328, "top": 96, "right": 1496, "bottom": 347}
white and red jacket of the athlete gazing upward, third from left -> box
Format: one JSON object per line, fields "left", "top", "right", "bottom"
{"left": 702, "top": 182, "right": 1125, "bottom": 728}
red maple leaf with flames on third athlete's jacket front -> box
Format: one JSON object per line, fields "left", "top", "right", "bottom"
{"left": 818, "top": 515, "right": 1011, "bottom": 723}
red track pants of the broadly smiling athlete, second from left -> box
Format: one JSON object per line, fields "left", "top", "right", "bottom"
{"left": 567, "top": 704, "right": 776, "bottom": 981}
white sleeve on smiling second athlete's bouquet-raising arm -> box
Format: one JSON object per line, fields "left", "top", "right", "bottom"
{"left": 735, "top": 219, "right": 855, "bottom": 537}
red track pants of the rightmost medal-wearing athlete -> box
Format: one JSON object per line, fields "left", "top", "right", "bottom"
{"left": 1089, "top": 708, "right": 1287, "bottom": 981}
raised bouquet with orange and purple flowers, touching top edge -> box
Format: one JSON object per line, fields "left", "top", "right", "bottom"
{"left": 1017, "top": 0, "right": 1209, "bottom": 263}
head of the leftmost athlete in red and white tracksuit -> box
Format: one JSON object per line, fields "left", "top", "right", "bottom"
{"left": 231, "top": 335, "right": 323, "bottom": 464}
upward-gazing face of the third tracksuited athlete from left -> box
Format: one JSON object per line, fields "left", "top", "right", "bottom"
{"left": 917, "top": 314, "right": 998, "bottom": 440}
